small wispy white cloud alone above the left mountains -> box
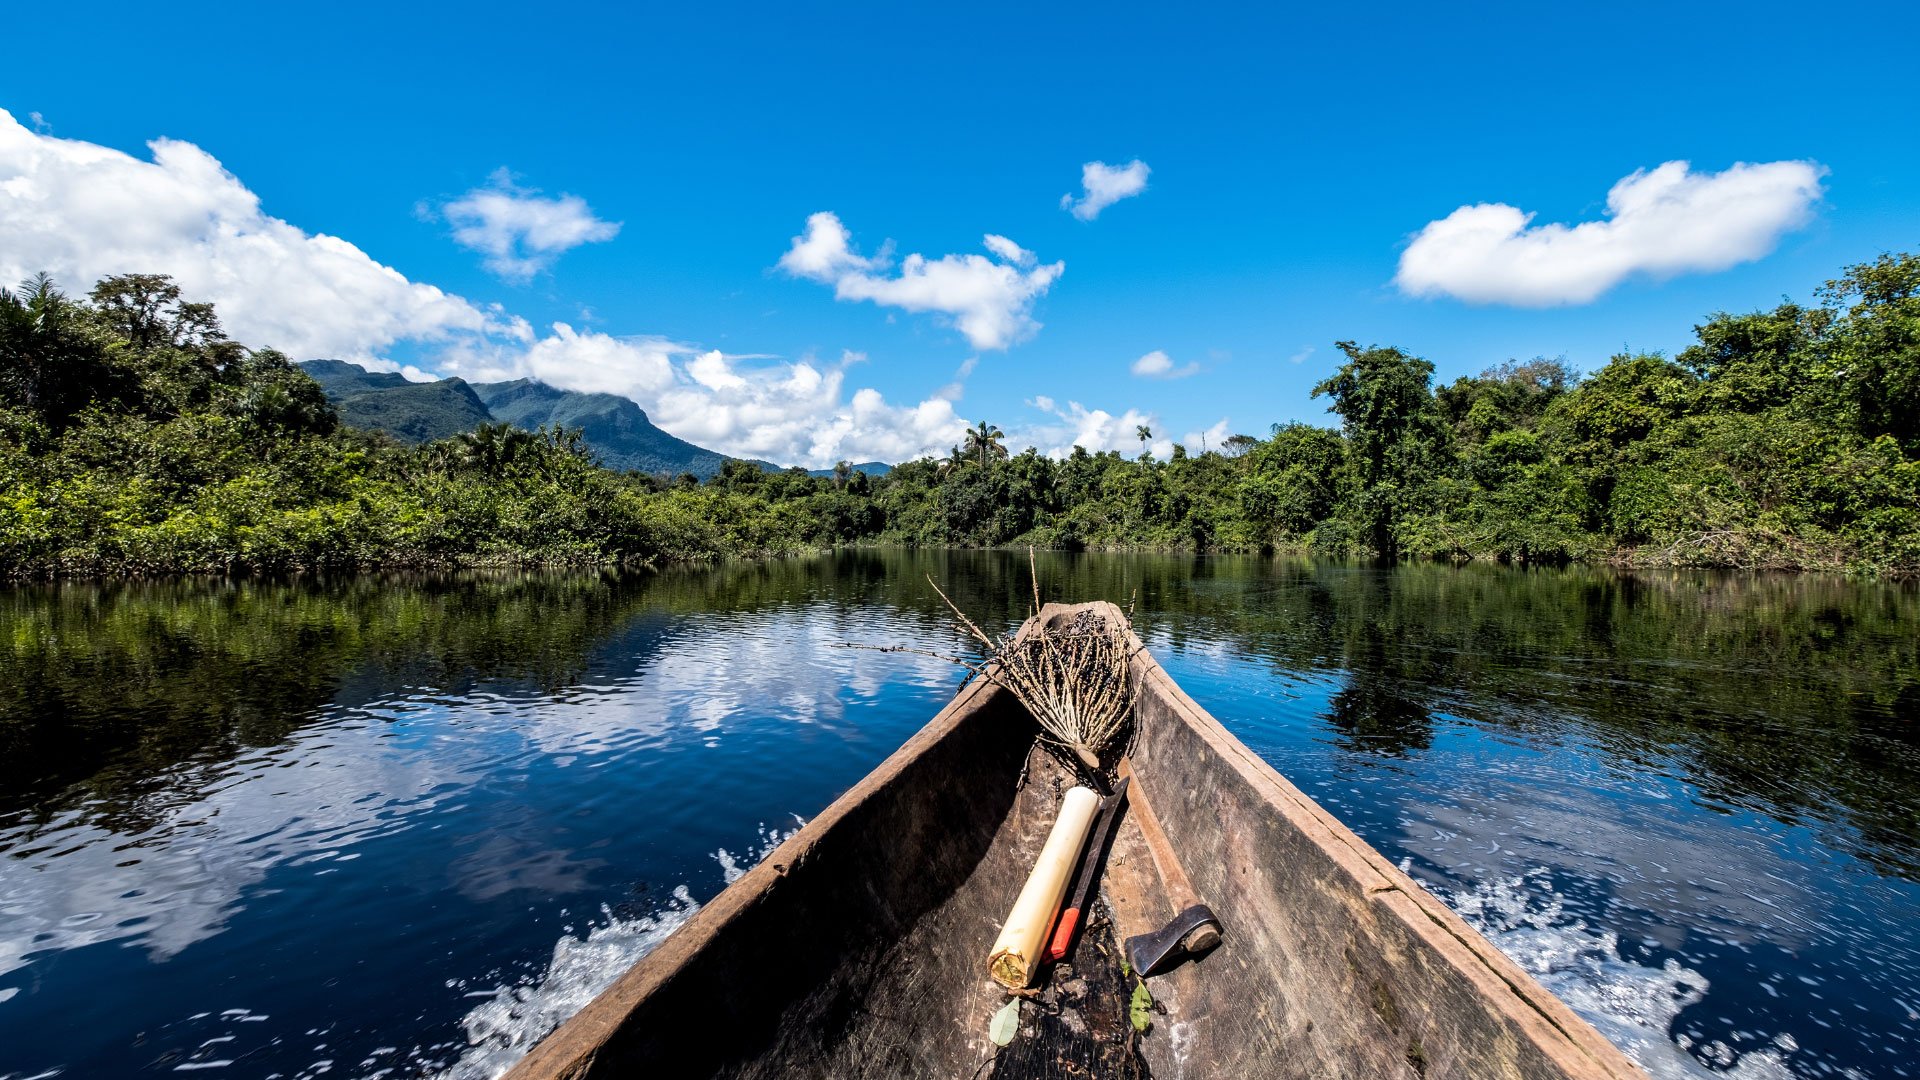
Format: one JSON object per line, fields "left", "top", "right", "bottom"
{"left": 440, "top": 167, "right": 620, "bottom": 281}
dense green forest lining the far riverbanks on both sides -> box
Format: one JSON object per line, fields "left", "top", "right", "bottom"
{"left": 0, "top": 256, "right": 1920, "bottom": 577}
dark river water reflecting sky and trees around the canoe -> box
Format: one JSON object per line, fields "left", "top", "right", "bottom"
{"left": 0, "top": 552, "right": 1920, "bottom": 1080}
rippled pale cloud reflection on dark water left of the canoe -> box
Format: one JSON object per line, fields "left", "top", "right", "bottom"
{"left": 0, "top": 609, "right": 952, "bottom": 1005}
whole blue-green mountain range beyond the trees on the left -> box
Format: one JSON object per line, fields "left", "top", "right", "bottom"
{"left": 300, "top": 359, "right": 752, "bottom": 480}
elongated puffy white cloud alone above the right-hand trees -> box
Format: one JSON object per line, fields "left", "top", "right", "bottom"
{"left": 1394, "top": 161, "right": 1826, "bottom": 307}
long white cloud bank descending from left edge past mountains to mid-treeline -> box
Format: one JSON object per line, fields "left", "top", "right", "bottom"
{"left": 0, "top": 111, "right": 983, "bottom": 467}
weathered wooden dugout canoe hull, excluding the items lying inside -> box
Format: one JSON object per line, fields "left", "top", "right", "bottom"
{"left": 509, "top": 603, "right": 1644, "bottom": 1080}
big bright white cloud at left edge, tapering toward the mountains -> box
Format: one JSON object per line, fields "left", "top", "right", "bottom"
{"left": 0, "top": 110, "right": 505, "bottom": 359}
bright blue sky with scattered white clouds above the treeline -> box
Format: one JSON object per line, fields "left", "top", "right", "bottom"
{"left": 0, "top": 4, "right": 1920, "bottom": 465}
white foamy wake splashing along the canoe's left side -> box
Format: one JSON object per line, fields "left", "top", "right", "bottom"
{"left": 438, "top": 815, "right": 804, "bottom": 1080}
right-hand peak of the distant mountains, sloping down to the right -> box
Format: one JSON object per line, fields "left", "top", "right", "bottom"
{"left": 474, "top": 379, "right": 728, "bottom": 480}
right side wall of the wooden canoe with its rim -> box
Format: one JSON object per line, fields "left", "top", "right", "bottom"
{"left": 1108, "top": 630, "right": 1644, "bottom": 1080}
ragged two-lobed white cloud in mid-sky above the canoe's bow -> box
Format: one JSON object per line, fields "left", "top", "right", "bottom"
{"left": 780, "top": 211, "right": 1066, "bottom": 350}
